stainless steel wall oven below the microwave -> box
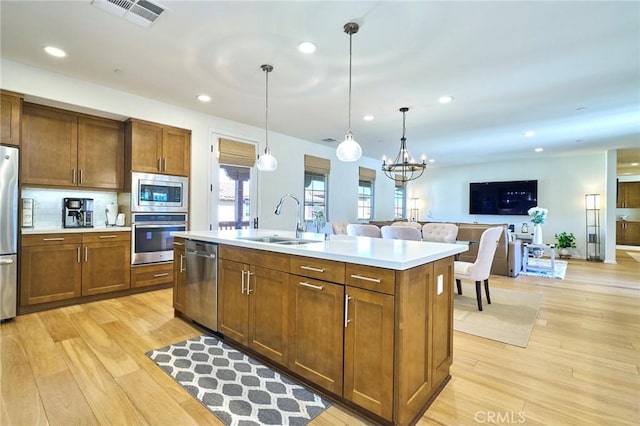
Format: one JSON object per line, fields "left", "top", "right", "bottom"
{"left": 131, "top": 213, "right": 187, "bottom": 265}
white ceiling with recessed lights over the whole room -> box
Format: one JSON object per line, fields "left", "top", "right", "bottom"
{"left": 0, "top": 0, "right": 640, "bottom": 174}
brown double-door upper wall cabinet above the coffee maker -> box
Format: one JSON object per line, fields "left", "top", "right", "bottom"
{"left": 22, "top": 103, "right": 124, "bottom": 190}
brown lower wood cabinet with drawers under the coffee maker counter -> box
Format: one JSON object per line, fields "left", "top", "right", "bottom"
{"left": 20, "top": 232, "right": 131, "bottom": 306}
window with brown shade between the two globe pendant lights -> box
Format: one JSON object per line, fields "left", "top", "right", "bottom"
{"left": 304, "top": 155, "right": 331, "bottom": 221}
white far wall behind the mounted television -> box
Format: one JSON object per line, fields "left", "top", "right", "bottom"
{"left": 408, "top": 152, "right": 606, "bottom": 257}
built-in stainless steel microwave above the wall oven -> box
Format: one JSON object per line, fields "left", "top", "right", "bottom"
{"left": 131, "top": 172, "right": 189, "bottom": 213}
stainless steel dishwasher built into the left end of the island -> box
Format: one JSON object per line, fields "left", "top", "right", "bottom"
{"left": 185, "top": 240, "right": 218, "bottom": 331}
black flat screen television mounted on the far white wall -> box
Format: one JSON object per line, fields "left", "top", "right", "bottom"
{"left": 469, "top": 180, "right": 538, "bottom": 216}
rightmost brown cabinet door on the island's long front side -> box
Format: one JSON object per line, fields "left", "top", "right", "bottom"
{"left": 344, "top": 286, "right": 394, "bottom": 420}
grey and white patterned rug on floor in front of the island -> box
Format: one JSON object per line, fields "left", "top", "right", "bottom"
{"left": 146, "top": 336, "right": 331, "bottom": 426}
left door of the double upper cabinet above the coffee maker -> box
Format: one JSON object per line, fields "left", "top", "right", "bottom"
{"left": 21, "top": 104, "right": 78, "bottom": 186}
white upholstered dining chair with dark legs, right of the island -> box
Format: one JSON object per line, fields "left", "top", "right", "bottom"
{"left": 453, "top": 226, "right": 504, "bottom": 311}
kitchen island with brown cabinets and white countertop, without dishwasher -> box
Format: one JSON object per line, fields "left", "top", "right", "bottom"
{"left": 172, "top": 230, "right": 467, "bottom": 425}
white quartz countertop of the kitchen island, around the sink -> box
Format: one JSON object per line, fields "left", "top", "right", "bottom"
{"left": 171, "top": 229, "right": 468, "bottom": 271}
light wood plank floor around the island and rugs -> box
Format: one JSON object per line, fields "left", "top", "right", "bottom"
{"left": 0, "top": 251, "right": 640, "bottom": 426}
